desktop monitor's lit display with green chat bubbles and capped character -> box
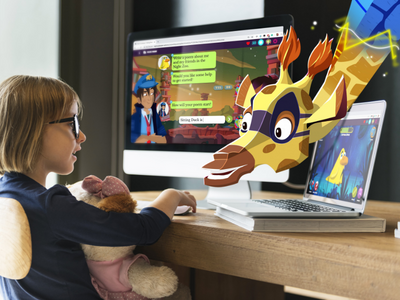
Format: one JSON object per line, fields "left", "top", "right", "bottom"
{"left": 129, "top": 26, "right": 284, "bottom": 145}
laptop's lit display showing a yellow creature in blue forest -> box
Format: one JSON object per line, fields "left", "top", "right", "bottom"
{"left": 307, "top": 115, "right": 380, "bottom": 204}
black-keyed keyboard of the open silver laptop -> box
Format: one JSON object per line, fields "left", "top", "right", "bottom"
{"left": 253, "top": 199, "right": 345, "bottom": 212}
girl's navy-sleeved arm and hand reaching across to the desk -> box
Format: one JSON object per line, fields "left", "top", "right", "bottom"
{"left": 45, "top": 185, "right": 196, "bottom": 247}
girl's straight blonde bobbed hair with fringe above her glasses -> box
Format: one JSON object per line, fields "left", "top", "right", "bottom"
{"left": 0, "top": 75, "right": 82, "bottom": 174}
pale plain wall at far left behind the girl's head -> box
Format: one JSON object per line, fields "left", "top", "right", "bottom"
{"left": 0, "top": 0, "right": 59, "bottom": 186}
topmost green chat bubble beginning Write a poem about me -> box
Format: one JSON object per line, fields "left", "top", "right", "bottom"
{"left": 172, "top": 52, "right": 217, "bottom": 71}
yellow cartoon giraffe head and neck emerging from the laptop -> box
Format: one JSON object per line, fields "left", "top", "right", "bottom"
{"left": 203, "top": 0, "right": 400, "bottom": 187}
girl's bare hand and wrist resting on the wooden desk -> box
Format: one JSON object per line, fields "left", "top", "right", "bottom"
{"left": 148, "top": 189, "right": 196, "bottom": 220}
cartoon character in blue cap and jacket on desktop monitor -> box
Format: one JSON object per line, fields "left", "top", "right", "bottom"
{"left": 131, "top": 74, "right": 167, "bottom": 144}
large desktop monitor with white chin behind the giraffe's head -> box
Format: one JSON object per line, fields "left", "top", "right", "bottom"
{"left": 123, "top": 15, "right": 293, "bottom": 204}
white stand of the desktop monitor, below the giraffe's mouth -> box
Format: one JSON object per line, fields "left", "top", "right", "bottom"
{"left": 197, "top": 180, "right": 251, "bottom": 209}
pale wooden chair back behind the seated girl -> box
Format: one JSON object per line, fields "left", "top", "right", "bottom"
{"left": 0, "top": 197, "right": 32, "bottom": 279}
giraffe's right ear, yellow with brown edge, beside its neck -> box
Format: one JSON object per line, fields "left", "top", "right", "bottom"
{"left": 304, "top": 76, "right": 347, "bottom": 143}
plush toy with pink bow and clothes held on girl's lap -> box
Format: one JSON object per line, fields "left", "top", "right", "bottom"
{"left": 68, "top": 175, "right": 191, "bottom": 300}
